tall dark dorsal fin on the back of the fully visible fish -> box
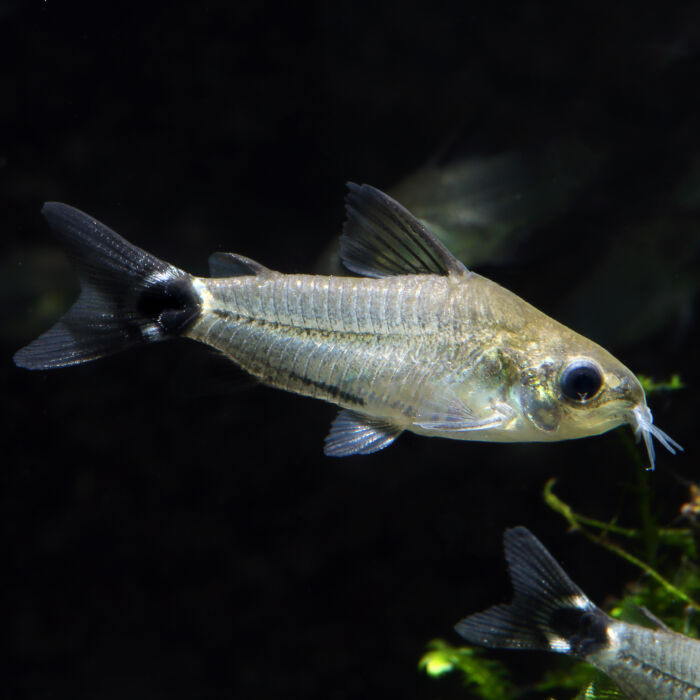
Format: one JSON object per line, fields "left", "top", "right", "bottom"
{"left": 340, "top": 182, "right": 468, "bottom": 277}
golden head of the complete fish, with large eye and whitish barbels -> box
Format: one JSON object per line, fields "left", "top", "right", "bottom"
{"left": 520, "top": 336, "right": 682, "bottom": 469}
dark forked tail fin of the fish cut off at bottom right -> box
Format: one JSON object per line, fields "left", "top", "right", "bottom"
{"left": 455, "top": 527, "right": 609, "bottom": 658}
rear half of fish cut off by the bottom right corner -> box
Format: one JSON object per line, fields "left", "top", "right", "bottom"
{"left": 455, "top": 527, "right": 700, "bottom": 700}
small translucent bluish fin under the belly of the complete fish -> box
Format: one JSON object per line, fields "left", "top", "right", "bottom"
{"left": 323, "top": 408, "right": 402, "bottom": 457}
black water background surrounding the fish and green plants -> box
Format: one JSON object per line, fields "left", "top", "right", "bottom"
{"left": 0, "top": 0, "right": 700, "bottom": 699}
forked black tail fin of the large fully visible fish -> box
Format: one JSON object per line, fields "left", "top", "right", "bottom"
{"left": 14, "top": 202, "right": 199, "bottom": 369}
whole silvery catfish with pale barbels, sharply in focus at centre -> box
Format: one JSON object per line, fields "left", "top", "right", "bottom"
{"left": 15, "top": 183, "right": 679, "bottom": 466}
